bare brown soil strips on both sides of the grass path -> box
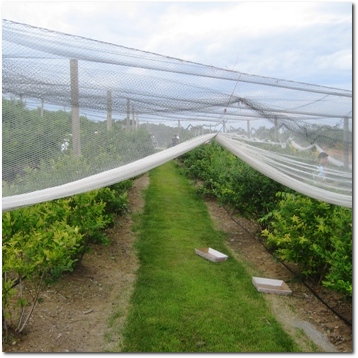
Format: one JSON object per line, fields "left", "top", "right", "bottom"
{"left": 3, "top": 175, "right": 352, "bottom": 352}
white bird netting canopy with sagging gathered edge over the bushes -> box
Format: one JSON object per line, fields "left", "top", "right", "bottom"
{"left": 2, "top": 20, "right": 352, "bottom": 210}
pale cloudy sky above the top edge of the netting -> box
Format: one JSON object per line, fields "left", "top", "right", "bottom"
{"left": 1, "top": 1, "right": 353, "bottom": 89}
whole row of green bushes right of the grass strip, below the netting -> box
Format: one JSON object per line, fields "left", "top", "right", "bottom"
{"left": 179, "top": 142, "right": 352, "bottom": 297}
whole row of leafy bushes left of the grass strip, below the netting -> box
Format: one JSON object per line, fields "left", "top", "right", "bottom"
{"left": 2, "top": 180, "right": 132, "bottom": 337}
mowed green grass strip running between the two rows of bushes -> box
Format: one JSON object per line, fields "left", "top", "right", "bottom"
{"left": 121, "top": 162, "right": 299, "bottom": 352}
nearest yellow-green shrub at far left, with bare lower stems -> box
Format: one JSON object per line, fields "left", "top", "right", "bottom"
{"left": 2, "top": 201, "right": 83, "bottom": 336}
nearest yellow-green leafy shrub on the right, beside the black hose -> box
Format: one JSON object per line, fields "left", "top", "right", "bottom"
{"left": 260, "top": 193, "right": 352, "bottom": 296}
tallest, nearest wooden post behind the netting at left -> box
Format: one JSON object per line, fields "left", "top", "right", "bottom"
{"left": 70, "top": 59, "right": 81, "bottom": 157}
